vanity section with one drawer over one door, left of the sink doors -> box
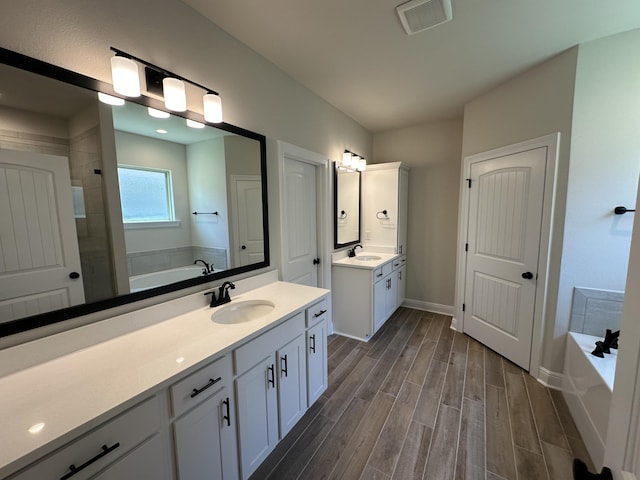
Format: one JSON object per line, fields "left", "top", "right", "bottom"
{"left": 170, "top": 355, "right": 238, "bottom": 480}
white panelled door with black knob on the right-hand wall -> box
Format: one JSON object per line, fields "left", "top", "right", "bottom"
{"left": 464, "top": 148, "right": 547, "bottom": 370}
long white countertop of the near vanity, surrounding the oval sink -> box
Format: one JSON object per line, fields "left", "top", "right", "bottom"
{"left": 0, "top": 282, "right": 329, "bottom": 478}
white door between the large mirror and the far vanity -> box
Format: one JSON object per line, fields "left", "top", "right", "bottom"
{"left": 282, "top": 156, "right": 318, "bottom": 287}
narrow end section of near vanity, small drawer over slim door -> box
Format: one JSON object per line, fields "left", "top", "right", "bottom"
{"left": 306, "top": 299, "right": 328, "bottom": 407}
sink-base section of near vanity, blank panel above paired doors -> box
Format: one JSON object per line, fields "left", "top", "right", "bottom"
{"left": 234, "top": 312, "right": 307, "bottom": 479}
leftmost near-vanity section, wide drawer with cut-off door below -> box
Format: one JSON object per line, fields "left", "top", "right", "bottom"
{"left": 8, "top": 396, "right": 173, "bottom": 480}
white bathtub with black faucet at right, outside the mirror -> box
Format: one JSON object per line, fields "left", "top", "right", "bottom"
{"left": 562, "top": 332, "right": 618, "bottom": 469}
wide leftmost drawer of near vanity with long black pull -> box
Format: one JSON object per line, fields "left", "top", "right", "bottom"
{"left": 13, "top": 397, "right": 160, "bottom": 480}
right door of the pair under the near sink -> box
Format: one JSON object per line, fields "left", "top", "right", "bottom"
{"left": 278, "top": 335, "right": 307, "bottom": 438}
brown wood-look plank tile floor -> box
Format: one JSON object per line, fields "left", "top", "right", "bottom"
{"left": 251, "top": 308, "right": 595, "bottom": 480}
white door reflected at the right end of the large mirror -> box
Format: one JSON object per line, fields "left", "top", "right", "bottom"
{"left": 232, "top": 175, "right": 264, "bottom": 267}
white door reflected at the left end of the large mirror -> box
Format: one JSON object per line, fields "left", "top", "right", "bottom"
{"left": 0, "top": 150, "right": 84, "bottom": 321}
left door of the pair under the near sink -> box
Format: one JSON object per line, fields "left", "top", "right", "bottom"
{"left": 236, "top": 355, "right": 278, "bottom": 479}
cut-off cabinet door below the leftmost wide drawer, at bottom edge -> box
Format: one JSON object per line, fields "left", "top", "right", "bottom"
{"left": 93, "top": 435, "right": 170, "bottom": 480}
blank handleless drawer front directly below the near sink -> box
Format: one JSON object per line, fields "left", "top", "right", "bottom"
{"left": 233, "top": 312, "right": 305, "bottom": 375}
